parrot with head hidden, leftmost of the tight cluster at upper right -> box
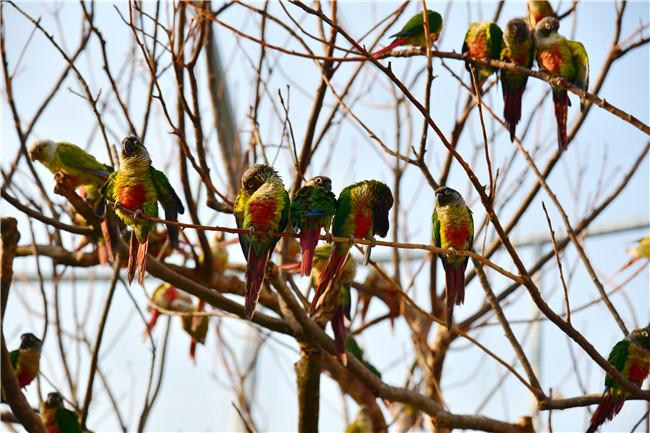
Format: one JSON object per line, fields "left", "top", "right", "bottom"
{"left": 462, "top": 21, "right": 503, "bottom": 89}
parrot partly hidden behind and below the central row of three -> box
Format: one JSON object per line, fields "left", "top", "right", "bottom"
{"left": 311, "top": 243, "right": 357, "bottom": 365}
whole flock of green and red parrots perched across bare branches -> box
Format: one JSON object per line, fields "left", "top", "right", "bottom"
{"left": 3, "top": 1, "right": 650, "bottom": 433}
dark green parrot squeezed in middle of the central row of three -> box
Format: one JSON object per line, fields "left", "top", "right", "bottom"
{"left": 291, "top": 176, "right": 336, "bottom": 277}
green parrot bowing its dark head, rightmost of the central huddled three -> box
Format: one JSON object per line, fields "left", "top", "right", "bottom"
{"left": 310, "top": 180, "right": 393, "bottom": 311}
